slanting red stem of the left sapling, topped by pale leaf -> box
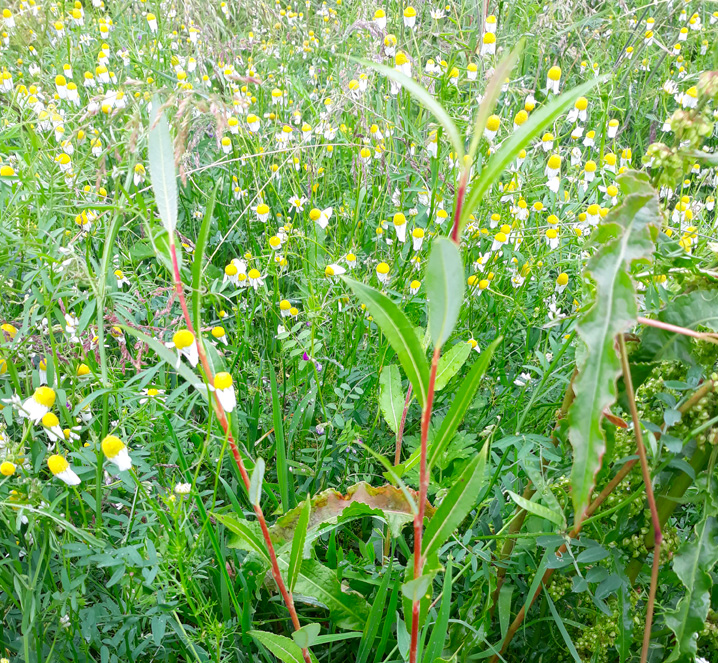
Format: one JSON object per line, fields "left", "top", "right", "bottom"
{"left": 170, "top": 241, "right": 312, "bottom": 663}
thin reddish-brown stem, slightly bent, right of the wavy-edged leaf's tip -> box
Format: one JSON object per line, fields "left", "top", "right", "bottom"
{"left": 618, "top": 334, "right": 663, "bottom": 663}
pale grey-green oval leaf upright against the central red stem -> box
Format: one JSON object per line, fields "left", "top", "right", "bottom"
{"left": 426, "top": 237, "right": 464, "bottom": 348}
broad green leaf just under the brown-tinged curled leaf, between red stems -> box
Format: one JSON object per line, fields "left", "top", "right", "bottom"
{"left": 278, "top": 557, "right": 369, "bottom": 631}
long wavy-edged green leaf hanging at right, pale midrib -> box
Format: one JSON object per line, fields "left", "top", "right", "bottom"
{"left": 568, "top": 172, "right": 660, "bottom": 523}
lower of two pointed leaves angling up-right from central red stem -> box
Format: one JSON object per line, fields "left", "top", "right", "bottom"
{"left": 422, "top": 444, "right": 488, "bottom": 557}
